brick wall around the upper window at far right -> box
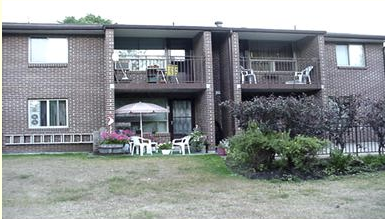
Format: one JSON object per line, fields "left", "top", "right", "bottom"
{"left": 323, "top": 42, "right": 385, "bottom": 100}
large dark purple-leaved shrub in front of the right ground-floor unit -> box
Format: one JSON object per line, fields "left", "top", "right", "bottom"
{"left": 223, "top": 95, "right": 323, "bottom": 137}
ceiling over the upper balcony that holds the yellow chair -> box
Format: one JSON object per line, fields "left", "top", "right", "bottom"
{"left": 115, "top": 29, "right": 202, "bottom": 38}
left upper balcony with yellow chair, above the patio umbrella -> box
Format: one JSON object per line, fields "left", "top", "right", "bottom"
{"left": 114, "top": 55, "right": 205, "bottom": 92}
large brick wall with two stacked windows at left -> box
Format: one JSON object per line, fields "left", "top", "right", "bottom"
{"left": 2, "top": 34, "right": 105, "bottom": 149}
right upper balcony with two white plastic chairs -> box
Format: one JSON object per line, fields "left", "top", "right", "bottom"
{"left": 241, "top": 58, "right": 321, "bottom": 93}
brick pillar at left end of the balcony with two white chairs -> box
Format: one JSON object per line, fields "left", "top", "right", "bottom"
{"left": 230, "top": 33, "right": 242, "bottom": 134}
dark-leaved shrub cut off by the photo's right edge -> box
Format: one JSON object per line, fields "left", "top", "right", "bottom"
{"left": 362, "top": 97, "right": 385, "bottom": 154}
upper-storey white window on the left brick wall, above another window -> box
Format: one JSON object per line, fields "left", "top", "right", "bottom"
{"left": 29, "top": 37, "right": 68, "bottom": 64}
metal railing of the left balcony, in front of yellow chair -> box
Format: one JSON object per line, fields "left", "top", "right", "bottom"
{"left": 114, "top": 56, "right": 205, "bottom": 84}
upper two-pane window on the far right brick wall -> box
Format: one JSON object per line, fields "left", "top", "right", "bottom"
{"left": 336, "top": 44, "right": 365, "bottom": 67}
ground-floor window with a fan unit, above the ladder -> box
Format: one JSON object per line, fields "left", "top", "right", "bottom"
{"left": 28, "top": 100, "right": 68, "bottom": 128}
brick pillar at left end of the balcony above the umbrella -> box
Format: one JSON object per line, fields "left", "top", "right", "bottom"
{"left": 103, "top": 29, "right": 115, "bottom": 128}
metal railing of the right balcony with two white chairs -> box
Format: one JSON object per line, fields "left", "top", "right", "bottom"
{"left": 240, "top": 58, "right": 320, "bottom": 88}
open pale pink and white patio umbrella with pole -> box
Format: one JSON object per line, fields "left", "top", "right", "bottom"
{"left": 115, "top": 102, "right": 169, "bottom": 138}
